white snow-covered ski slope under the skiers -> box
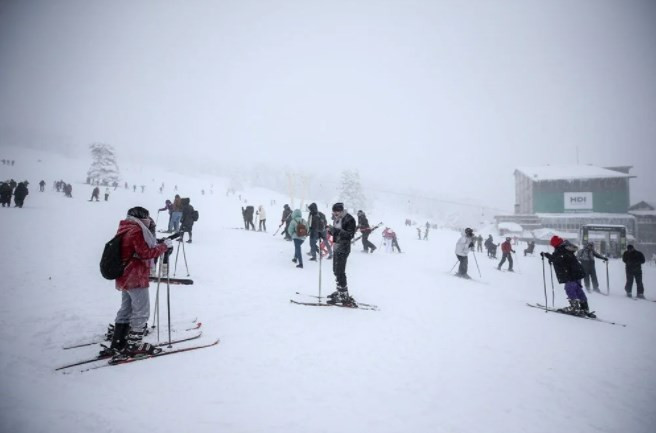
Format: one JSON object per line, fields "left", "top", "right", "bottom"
{"left": 0, "top": 149, "right": 656, "bottom": 433}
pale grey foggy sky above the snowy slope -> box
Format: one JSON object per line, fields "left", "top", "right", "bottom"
{"left": 0, "top": 0, "right": 656, "bottom": 210}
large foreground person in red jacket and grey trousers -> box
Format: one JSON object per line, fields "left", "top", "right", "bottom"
{"left": 100, "top": 206, "right": 172, "bottom": 357}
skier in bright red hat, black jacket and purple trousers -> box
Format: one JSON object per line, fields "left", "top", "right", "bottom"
{"left": 540, "top": 236, "right": 596, "bottom": 318}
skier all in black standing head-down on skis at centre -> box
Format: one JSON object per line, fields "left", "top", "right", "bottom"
{"left": 327, "top": 203, "right": 356, "bottom": 306}
